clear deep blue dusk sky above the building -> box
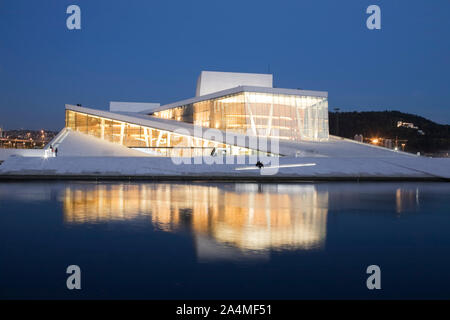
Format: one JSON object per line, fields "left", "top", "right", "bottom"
{"left": 0, "top": 0, "right": 450, "bottom": 130}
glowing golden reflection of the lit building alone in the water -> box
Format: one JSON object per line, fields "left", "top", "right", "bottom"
{"left": 62, "top": 184, "right": 328, "bottom": 256}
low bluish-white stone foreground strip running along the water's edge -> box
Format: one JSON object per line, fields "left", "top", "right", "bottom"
{"left": 0, "top": 156, "right": 450, "bottom": 181}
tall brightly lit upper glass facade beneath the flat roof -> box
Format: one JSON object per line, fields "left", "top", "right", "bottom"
{"left": 153, "top": 92, "right": 328, "bottom": 141}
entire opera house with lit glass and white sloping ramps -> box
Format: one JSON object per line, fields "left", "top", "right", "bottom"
{"left": 0, "top": 71, "right": 450, "bottom": 181}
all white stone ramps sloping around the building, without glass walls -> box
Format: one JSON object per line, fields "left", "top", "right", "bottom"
{"left": 0, "top": 130, "right": 450, "bottom": 180}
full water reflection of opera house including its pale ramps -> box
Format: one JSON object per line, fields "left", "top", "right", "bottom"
{"left": 0, "top": 183, "right": 430, "bottom": 260}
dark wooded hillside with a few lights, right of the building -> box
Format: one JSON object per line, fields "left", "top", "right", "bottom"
{"left": 329, "top": 111, "right": 450, "bottom": 154}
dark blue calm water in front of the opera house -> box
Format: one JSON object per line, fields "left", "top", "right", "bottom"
{"left": 0, "top": 182, "right": 450, "bottom": 299}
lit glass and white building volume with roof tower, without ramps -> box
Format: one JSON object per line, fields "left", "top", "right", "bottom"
{"left": 66, "top": 71, "right": 329, "bottom": 157}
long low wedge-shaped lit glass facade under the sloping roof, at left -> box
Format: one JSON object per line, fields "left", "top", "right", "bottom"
{"left": 66, "top": 110, "right": 266, "bottom": 157}
